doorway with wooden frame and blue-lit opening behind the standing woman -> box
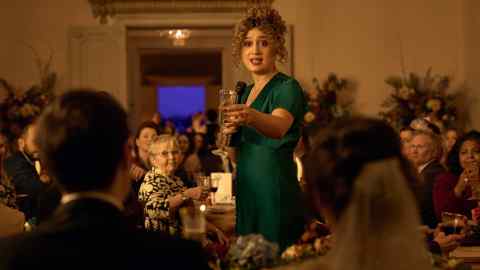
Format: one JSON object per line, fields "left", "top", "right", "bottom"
{"left": 127, "top": 27, "right": 240, "bottom": 127}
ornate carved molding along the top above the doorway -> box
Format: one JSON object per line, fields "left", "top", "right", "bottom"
{"left": 88, "top": 0, "right": 274, "bottom": 24}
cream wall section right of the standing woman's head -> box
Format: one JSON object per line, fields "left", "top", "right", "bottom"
{"left": 274, "top": 0, "right": 464, "bottom": 118}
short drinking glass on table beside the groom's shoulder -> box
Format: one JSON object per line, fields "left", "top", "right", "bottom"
{"left": 180, "top": 204, "right": 206, "bottom": 243}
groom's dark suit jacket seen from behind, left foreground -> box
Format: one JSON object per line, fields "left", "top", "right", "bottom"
{"left": 0, "top": 200, "right": 209, "bottom": 269}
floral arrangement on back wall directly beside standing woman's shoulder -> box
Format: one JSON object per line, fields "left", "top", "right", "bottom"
{"left": 304, "top": 73, "right": 352, "bottom": 127}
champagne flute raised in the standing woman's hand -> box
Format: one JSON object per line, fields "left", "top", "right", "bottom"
{"left": 212, "top": 89, "right": 238, "bottom": 156}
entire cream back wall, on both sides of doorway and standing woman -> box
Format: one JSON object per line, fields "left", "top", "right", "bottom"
{"left": 0, "top": 0, "right": 472, "bottom": 125}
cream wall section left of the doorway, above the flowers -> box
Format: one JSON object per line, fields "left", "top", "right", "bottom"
{"left": 0, "top": 0, "right": 96, "bottom": 92}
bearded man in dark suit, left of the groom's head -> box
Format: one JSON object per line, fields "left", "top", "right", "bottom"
{"left": 4, "top": 123, "right": 50, "bottom": 220}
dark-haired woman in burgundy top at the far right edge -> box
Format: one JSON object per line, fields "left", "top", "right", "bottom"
{"left": 433, "top": 130, "right": 480, "bottom": 218}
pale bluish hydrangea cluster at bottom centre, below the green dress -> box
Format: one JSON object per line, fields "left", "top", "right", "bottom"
{"left": 222, "top": 234, "right": 278, "bottom": 270}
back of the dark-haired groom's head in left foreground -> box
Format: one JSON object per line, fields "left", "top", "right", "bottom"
{"left": 37, "top": 89, "right": 129, "bottom": 192}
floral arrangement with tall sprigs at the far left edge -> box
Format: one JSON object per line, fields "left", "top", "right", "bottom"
{"left": 0, "top": 46, "right": 57, "bottom": 140}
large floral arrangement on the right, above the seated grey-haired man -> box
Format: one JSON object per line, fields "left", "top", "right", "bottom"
{"left": 380, "top": 68, "right": 459, "bottom": 130}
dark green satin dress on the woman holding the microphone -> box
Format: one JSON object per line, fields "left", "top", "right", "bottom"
{"left": 232, "top": 73, "right": 307, "bottom": 250}
